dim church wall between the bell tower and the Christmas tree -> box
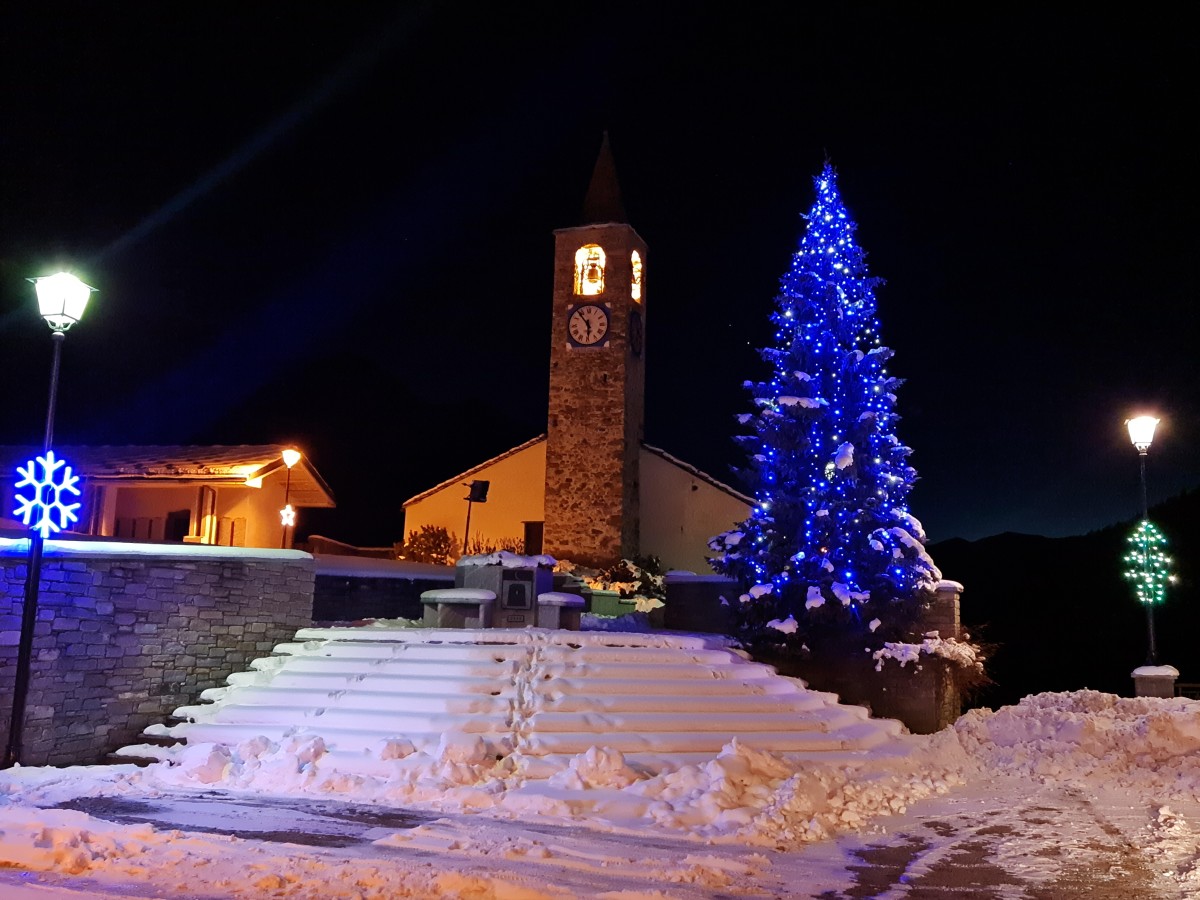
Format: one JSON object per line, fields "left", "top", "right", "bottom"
{"left": 641, "top": 450, "right": 750, "bottom": 574}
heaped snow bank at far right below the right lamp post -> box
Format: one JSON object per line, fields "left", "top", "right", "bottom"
{"left": 953, "top": 690, "right": 1200, "bottom": 800}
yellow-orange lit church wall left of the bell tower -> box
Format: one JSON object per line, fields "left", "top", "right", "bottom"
{"left": 404, "top": 440, "right": 546, "bottom": 554}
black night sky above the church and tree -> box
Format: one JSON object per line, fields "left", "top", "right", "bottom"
{"left": 0, "top": 2, "right": 1200, "bottom": 544}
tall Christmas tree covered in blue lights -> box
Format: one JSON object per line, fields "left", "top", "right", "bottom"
{"left": 709, "top": 163, "right": 941, "bottom": 653}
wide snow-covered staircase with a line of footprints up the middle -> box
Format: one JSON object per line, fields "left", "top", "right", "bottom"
{"left": 118, "top": 626, "right": 902, "bottom": 770}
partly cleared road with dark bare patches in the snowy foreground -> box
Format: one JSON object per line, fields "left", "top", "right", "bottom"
{"left": 23, "top": 776, "right": 1200, "bottom": 900}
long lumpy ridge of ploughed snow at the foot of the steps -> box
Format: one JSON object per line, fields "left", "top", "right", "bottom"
{"left": 132, "top": 734, "right": 961, "bottom": 846}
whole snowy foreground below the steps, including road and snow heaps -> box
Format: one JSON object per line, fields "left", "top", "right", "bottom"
{"left": 0, "top": 691, "right": 1200, "bottom": 899}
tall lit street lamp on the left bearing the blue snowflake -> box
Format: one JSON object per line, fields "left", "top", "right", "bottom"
{"left": 0, "top": 272, "right": 95, "bottom": 769}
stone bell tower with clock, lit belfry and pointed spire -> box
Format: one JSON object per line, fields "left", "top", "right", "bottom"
{"left": 544, "top": 133, "right": 646, "bottom": 565}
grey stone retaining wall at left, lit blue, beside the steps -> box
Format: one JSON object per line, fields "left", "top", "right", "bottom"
{"left": 0, "top": 542, "right": 313, "bottom": 766}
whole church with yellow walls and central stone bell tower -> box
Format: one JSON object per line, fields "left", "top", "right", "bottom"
{"left": 404, "top": 134, "right": 752, "bottom": 572}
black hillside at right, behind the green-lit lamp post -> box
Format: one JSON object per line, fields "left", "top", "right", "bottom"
{"left": 929, "top": 490, "right": 1200, "bottom": 707}
